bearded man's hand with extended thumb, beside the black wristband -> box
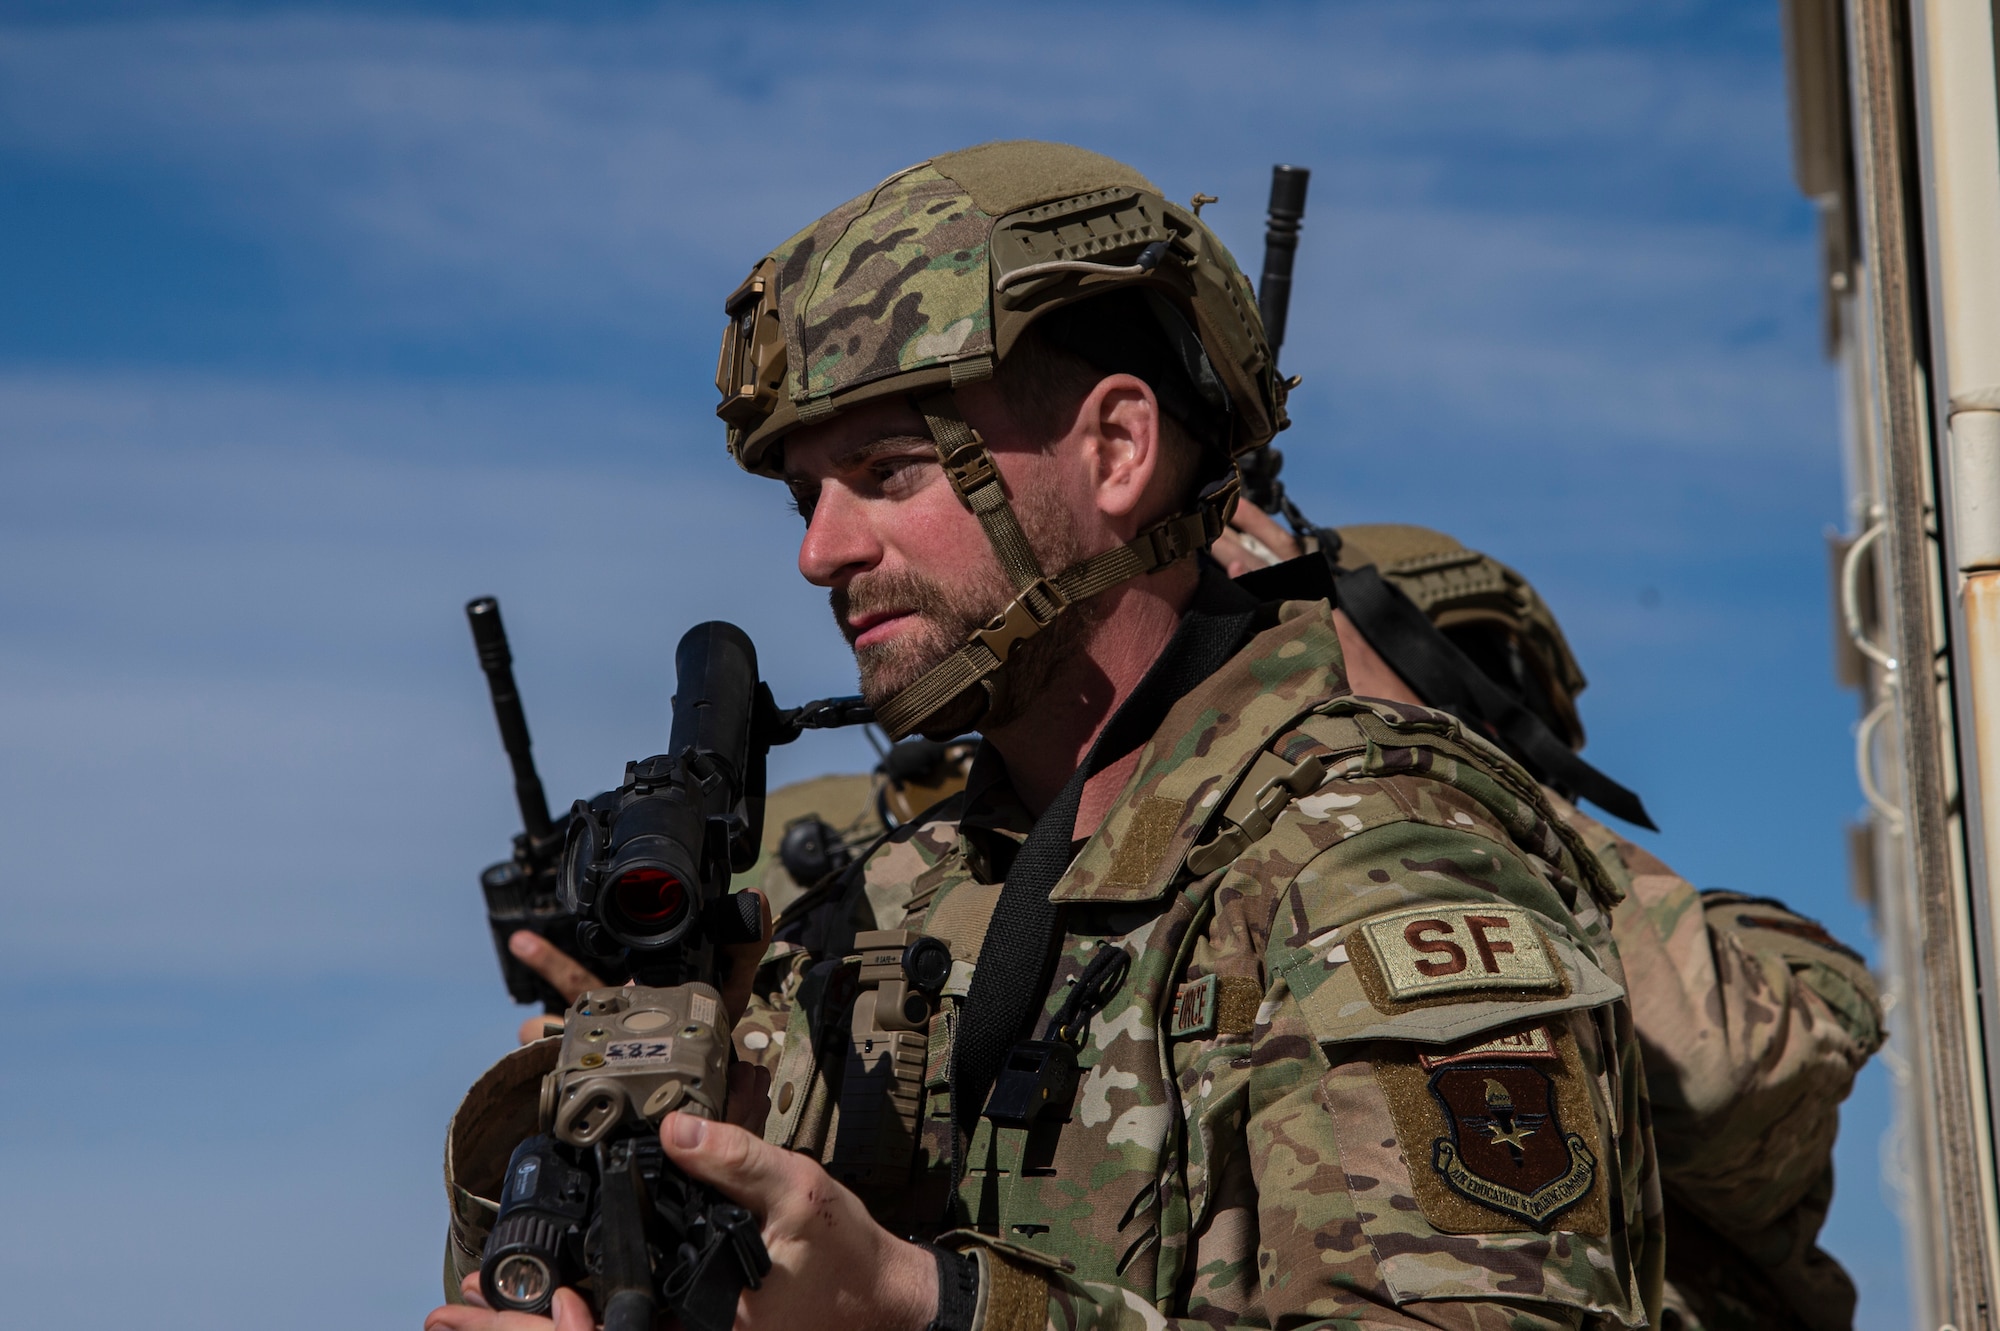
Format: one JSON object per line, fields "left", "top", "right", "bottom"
{"left": 656, "top": 1113, "right": 938, "bottom": 1331}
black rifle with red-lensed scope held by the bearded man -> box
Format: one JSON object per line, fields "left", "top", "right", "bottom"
{"left": 480, "top": 622, "right": 868, "bottom": 1331}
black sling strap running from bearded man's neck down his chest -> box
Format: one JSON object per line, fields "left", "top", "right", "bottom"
{"left": 948, "top": 558, "right": 1256, "bottom": 1219}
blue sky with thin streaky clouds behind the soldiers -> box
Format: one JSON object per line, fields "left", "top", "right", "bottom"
{"left": 0, "top": 0, "right": 1904, "bottom": 1327}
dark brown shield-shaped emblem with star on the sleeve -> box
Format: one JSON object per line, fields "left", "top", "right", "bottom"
{"left": 1430, "top": 1063, "right": 1598, "bottom": 1233}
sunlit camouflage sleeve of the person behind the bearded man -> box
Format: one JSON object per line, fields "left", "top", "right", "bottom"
{"left": 1554, "top": 801, "right": 1882, "bottom": 1327}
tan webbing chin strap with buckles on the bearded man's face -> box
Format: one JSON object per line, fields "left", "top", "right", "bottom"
{"left": 876, "top": 388, "right": 1242, "bottom": 739}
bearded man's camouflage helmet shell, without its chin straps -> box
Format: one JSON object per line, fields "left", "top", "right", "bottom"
{"left": 716, "top": 140, "right": 1288, "bottom": 476}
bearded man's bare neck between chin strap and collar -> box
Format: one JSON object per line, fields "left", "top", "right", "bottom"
{"left": 986, "top": 560, "right": 1200, "bottom": 837}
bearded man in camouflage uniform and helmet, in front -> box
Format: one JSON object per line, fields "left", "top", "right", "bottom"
{"left": 428, "top": 144, "right": 1664, "bottom": 1331}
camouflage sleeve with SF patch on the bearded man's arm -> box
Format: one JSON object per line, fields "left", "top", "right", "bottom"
{"left": 944, "top": 807, "right": 1656, "bottom": 1331}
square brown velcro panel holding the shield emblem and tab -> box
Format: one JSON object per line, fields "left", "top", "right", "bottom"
{"left": 1376, "top": 1025, "right": 1608, "bottom": 1235}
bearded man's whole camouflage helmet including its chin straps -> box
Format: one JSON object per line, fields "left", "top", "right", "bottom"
{"left": 716, "top": 142, "right": 1288, "bottom": 737}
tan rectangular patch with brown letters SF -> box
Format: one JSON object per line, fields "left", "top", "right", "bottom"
{"left": 1362, "top": 905, "right": 1562, "bottom": 1003}
